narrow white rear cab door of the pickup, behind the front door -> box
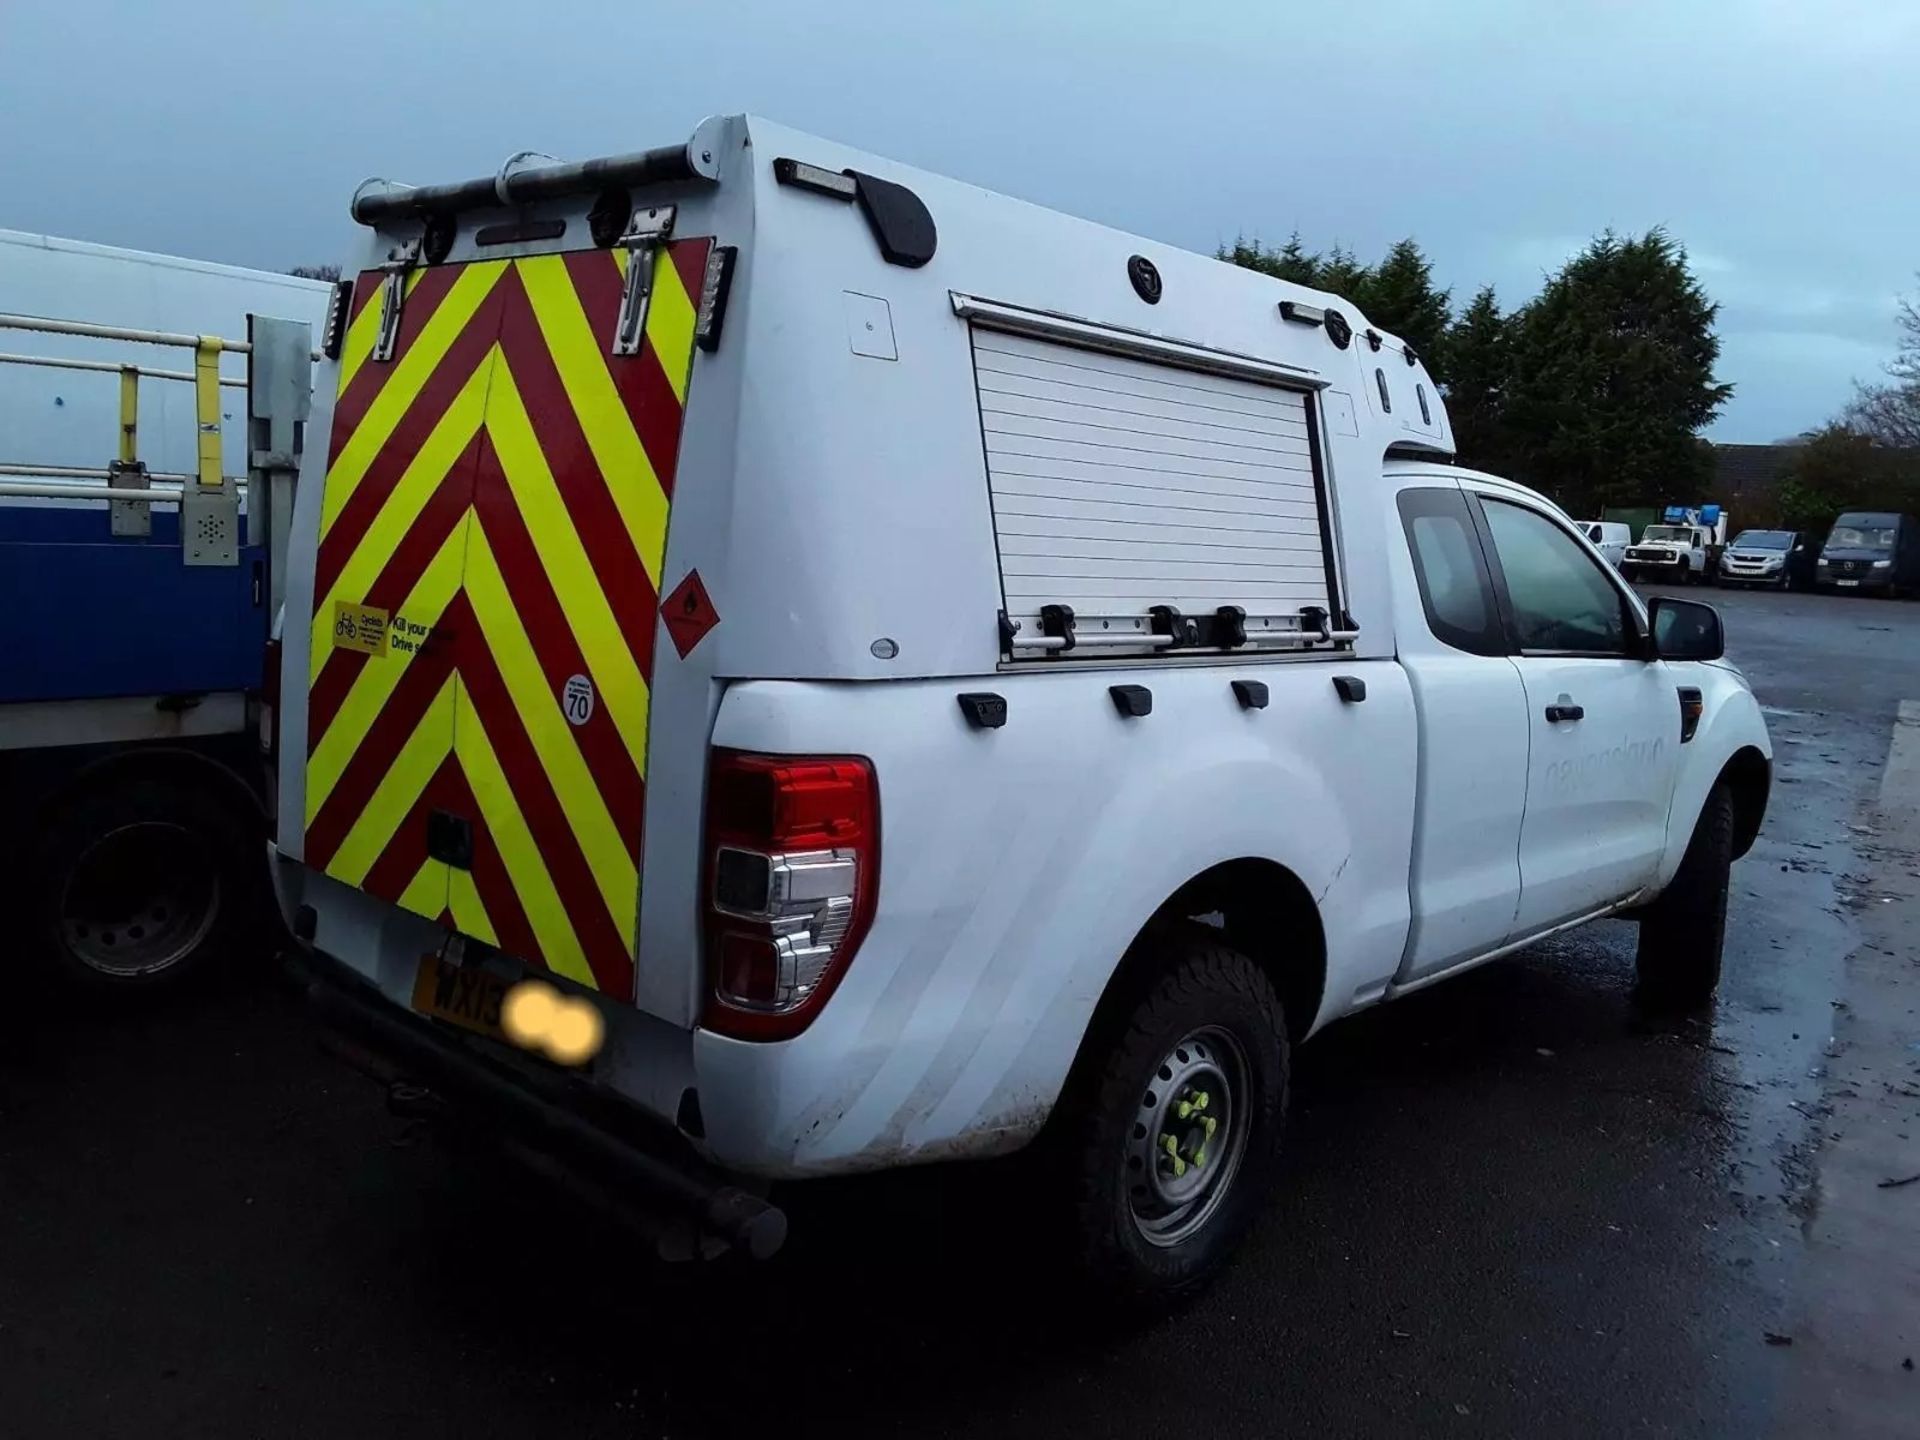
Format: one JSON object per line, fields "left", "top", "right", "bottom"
{"left": 1392, "top": 480, "right": 1528, "bottom": 985}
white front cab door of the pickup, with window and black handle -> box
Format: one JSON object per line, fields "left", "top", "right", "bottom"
{"left": 1475, "top": 492, "right": 1680, "bottom": 939}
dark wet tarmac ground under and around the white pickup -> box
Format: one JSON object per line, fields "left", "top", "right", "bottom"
{"left": 0, "top": 591, "right": 1920, "bottom": 1438}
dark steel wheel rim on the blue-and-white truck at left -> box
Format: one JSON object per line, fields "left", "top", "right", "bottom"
{"left": 58, "top": 820, "right": 221, "bottom": 979}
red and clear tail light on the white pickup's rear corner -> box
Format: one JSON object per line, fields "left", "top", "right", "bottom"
{"left": 705, "top": 751, "right": 879, "bottom": 1041}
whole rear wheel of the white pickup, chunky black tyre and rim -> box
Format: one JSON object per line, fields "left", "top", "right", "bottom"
{"left": 1058, "top": 924, "right": 1288, "bottom": 1311}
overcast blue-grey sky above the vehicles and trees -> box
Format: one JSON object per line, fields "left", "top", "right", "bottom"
{"left": 0, "top": 0, "right": 1920, "bottom": 440}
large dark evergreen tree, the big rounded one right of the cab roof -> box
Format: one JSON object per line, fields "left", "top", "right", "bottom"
{"left": 1503, "top": 230, "right": 1734, "bottom": 511}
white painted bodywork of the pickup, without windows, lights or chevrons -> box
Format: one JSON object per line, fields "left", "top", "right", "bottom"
{"left": 278, "top": 117, "right": 1766, "bottom": 1175}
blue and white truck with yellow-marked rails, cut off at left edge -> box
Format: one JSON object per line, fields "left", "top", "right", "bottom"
{"left": 0, "top": 230, "right": 332, "bottom": 991}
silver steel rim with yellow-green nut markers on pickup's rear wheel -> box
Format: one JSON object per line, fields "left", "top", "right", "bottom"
{"left": 1123, "top": 1025, "right": 1252, "bottom": 1248}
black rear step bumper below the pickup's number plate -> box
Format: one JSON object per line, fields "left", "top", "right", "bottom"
{"left": 290, "top": 950, "right": 787, "bottom": 1260}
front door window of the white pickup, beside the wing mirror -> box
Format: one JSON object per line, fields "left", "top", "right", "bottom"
{"left": 1482, "top": 495, "right": 1632, "bottom": 655}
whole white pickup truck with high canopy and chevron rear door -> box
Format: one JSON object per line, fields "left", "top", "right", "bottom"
{"left": 276, "top": 117, "right": 1770, "bottom": 1300}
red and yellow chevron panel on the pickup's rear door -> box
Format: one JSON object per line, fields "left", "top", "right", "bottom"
{"left": 305, "top": 240, "right": 708, "bottom": 995}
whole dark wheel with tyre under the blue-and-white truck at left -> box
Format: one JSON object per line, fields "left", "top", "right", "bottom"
{"left": 27, "top": 772, "right": 265, "bottom": 993}
